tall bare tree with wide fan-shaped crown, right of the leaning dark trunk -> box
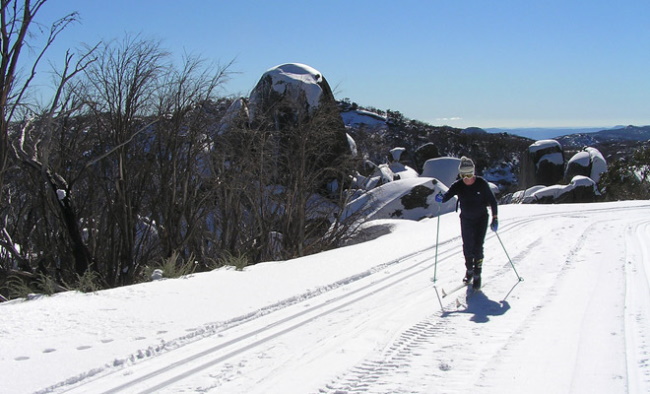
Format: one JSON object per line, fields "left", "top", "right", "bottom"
{"left": 78, "top": 36, "right": 169, "bottom": 285}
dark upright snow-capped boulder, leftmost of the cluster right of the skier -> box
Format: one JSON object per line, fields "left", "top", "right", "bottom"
{"left": 519, "top": 140, "right": 564, "bottom": 188}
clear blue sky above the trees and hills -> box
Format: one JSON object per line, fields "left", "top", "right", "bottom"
{"left": 37, "top": 0, "right": 650, "bottom": 128}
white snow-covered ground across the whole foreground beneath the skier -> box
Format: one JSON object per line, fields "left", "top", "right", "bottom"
{"left": 0, "top": 201, "right": 650, "bottom": 394}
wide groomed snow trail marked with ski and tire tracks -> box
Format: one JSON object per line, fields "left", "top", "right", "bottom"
{"left": 31, "top": 203, "right": 650, "bottom": 394}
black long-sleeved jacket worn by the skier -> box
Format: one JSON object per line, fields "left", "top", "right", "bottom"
{"left": 442, "top": 176, "right": 497, "bottom": 219}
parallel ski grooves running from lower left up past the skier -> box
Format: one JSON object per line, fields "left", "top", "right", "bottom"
{"left": 54, "top": 202, "right": 648, "bottom": 393}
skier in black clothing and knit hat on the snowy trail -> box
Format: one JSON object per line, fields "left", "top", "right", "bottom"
{"left": 435, "top": 156, "right": 499, "bottom": 289}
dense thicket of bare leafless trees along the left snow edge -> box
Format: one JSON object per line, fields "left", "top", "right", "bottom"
{"left": 0, "top": 0, "right": 354, "bottom": 298}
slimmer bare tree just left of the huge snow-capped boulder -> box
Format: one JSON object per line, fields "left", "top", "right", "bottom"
{"left": 148, "top": 57, "right": 232, "bottom": 258}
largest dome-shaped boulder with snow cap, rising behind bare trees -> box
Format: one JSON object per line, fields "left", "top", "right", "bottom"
{"left": 219, "top": 63, "right": 356, "bottom": 189}
